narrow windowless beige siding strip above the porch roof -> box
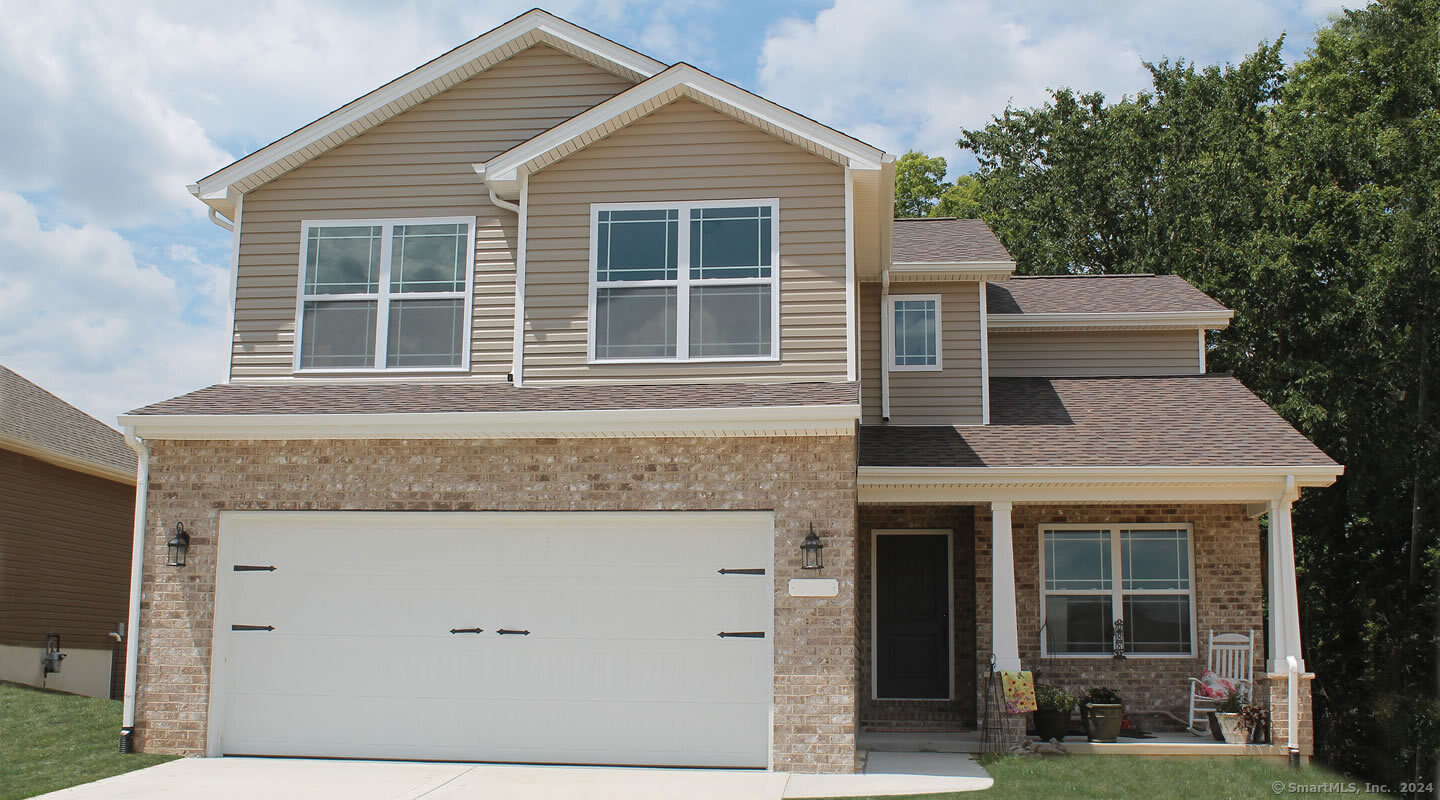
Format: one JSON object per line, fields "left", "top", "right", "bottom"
{"left": 989, "top": 328, "right": 1200, "bottom": 377}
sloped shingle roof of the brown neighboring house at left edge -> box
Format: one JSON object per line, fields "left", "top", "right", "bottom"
{"left": 0, "top": 367, "right": 135, "bottom": 483}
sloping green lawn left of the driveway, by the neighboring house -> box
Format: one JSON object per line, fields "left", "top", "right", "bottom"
{"left": 0, "top": 682, "right": 173, "bottom": 800}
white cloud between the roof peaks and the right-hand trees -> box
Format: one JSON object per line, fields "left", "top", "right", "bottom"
{"left": 759, "top": 0, "right": 1324, "bottom": 173}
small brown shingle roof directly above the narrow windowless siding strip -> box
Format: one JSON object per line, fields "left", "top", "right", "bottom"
{"left": 985, "top": 275, "right": 1225, "bottom": 315}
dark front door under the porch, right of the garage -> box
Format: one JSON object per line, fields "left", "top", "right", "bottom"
{"left": 874, "top": 534, "right": 950, "bottom": 699}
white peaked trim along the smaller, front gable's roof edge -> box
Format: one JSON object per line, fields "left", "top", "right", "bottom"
{"left": 475, "top": 62, "right": 890, "bottom": 199}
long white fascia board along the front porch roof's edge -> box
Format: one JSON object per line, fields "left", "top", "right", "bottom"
{"left": 858, "top": 465, "right": 1345, "bottom": 502}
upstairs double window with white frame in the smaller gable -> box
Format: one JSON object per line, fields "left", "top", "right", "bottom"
{"left": 590, "top": 200, "right": 780, "bottom": 361}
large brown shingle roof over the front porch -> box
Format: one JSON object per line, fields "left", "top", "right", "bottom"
{"left": 860, "top": 374, "right": 1335, "bottom": 466}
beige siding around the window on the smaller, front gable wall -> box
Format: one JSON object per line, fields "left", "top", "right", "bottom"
{"left": 526, "top": 99, "right": 845, "bottom": 383}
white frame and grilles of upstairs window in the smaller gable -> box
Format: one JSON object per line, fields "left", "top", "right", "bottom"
{"left": 586, "top": 197, "right": 780, "bottom": 364}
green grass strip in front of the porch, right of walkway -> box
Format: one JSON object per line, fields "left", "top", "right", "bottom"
{"left": 973, "top": 755, "right": 1381, "bottom": 800}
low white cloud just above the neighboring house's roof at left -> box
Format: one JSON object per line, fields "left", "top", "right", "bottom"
{"left": 0, "top": 191, "right": 228, "bottom": 424}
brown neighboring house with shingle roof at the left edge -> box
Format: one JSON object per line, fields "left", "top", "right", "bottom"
{"left": 0, "top": 367, "right": 135, "bottom": 699}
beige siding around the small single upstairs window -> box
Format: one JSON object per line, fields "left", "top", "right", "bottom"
{"left": 860, "top": 281, "right": 982, "bottom": 424}
